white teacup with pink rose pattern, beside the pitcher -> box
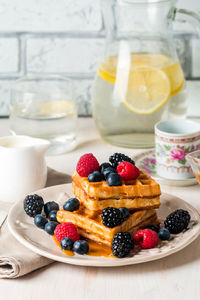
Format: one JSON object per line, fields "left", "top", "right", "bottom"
{"left": 155, "top": 120, "right": 200, "bottom": 180}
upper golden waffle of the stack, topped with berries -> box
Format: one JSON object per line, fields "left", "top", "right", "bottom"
{"left": 72, "top": 170, "right": 161, "bottom": 211}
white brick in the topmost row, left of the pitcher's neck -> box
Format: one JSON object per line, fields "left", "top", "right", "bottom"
{"left": 0, "top": 0, "right": 102, "bottom": 32}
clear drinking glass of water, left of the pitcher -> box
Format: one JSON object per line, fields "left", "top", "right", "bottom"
{"left": 10, "top": 75, "right": 77, "bottom": 154}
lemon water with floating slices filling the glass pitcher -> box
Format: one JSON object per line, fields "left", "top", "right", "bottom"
{"left": 93, "top": 53, "right": 187, "bottom": 147}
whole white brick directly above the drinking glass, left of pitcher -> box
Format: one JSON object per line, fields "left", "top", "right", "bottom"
{"left": 27, "top": 37, "right": 103, "bottom": 76}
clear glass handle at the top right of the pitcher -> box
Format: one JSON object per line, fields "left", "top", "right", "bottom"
{"left": 175, "top": 8, "right": 200, "bottom": 37}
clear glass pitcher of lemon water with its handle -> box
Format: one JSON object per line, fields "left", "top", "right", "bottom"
{"left": 93, "top": 0, "right": 200, "bottom": 148}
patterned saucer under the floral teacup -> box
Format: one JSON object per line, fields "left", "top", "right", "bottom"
{"left": 133, "top": 150, "right": 198, "bottom": 186}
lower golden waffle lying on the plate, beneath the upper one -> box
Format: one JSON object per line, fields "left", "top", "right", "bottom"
{"left": 57, "top": 206, "right": 159, "bottom": 246}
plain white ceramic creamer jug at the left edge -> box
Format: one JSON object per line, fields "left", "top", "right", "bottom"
{"left": 0, "top": 135, "right": 50, "bottom": 202}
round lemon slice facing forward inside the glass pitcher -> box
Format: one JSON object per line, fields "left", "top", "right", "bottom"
{"left": 118, "top": 66, "right": 171, "bottom": 114}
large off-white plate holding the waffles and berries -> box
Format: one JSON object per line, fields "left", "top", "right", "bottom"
{"left": 8, "top": 184, "right": 200, "bottom": 267}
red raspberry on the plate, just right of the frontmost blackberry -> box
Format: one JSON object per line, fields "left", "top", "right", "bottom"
{"left": 134, "top": 229, "right": 158, "bottom": 249}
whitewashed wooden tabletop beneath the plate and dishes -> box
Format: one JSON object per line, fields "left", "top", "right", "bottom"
{"left": 0, "top": 118, "right": 200, "bottom": 300}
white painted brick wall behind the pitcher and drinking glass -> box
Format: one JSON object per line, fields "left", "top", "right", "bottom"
{"left": 0, "top": 0, "right": 200, "bottom": 116}
